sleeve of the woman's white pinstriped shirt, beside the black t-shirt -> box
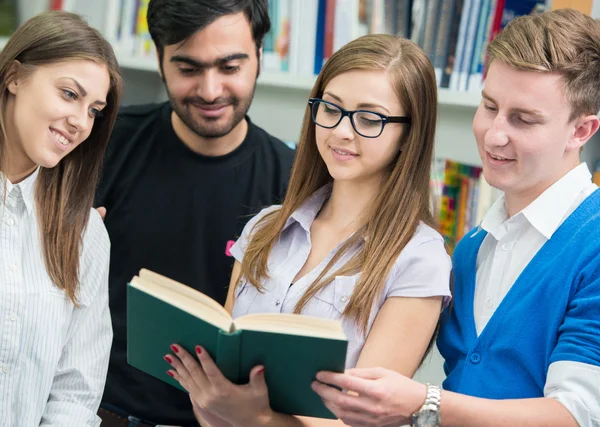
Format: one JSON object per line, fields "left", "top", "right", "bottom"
{"left": 40, "top": 210, "right": 112, "bottom": 427}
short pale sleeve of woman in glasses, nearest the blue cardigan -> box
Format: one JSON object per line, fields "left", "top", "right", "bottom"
{"left": 382, "top": 225, "right": 452, "bottom": 309}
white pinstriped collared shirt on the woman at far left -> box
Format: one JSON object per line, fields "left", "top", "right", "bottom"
{"left": 0, "top": 171, "right": 112, "bottom": 427}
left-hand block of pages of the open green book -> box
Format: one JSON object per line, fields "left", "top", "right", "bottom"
{"left": 131, "top": 269, "right": 233, "bottom": 332}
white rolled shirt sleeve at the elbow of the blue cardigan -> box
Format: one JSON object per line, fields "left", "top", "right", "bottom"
{"left": 544, "top": 361, "right": 600, "bottom": 427}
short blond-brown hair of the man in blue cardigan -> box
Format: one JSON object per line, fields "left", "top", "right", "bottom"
{"left": 486, "top": 9, "right": 600, "bottom": 120}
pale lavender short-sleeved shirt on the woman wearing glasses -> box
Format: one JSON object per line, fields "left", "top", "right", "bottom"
{"left": 231, "top": 186, "right": 451, "bottom": 368}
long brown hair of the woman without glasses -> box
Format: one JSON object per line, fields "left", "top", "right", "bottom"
{"left": 0, "top": 12, "right": 122, "bottom": 304}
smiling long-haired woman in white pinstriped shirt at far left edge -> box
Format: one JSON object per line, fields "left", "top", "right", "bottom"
{"left": 0, "top": 12, "right": 121, "bottom": 426}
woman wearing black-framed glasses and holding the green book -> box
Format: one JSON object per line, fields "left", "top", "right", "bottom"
{"left": 167, "top": 35, "right": 451, "bottom": 427}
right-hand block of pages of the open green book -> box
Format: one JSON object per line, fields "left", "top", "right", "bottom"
{"left": 234, "top": 313, "right": 346, "bottom": 341}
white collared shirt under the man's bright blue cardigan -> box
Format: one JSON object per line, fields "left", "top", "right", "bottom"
{"left": 474, "top": 163, "right": 600, "bottom": 427}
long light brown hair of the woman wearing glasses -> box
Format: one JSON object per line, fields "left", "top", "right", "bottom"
{"left": 240, "top": 34, "right": 437, "bottom": 333}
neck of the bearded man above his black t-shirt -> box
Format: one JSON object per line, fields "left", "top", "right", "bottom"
{"left": 171, "top": 111, "right": 248, "bottom": 157}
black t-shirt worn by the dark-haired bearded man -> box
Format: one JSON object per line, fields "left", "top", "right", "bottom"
{"left": 95, "top": 103, "right": 294, "bottom": 425}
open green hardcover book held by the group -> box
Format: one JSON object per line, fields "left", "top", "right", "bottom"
{"left": 127, "top": 269, "right": 348, "bottom": 419}
